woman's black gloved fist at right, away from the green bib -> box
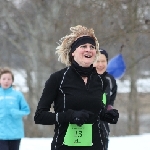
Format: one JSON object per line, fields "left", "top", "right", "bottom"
{"left": 100, "top": 109, "right": 119, "bottom": 124}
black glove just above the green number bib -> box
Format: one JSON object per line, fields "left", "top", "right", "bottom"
{"left": 58, "top": 109, "right": 93, "bottom": 126}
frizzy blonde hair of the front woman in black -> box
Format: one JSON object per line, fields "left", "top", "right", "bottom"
{"left": 56, "top": 25, "right": 99, "bottom": 66}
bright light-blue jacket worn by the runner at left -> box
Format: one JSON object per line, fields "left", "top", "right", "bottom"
{"left": 0, "top": 87, "right": 30, "bottom": 140}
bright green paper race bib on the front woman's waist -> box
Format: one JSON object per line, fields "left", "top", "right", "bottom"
{"left": 64, "top": 124, "right": 93, "bottom": 146}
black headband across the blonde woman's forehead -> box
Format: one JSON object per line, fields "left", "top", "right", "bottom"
{"left": 71, "top": 36, "right": 96, "bottom": 53}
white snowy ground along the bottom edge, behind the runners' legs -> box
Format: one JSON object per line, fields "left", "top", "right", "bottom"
{"left": 20, "top": 134, "right": 150, "bottom": 150}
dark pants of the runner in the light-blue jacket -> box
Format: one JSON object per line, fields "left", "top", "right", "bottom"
{"left": 0, "top": 139, "right": 21, "bottom": 150}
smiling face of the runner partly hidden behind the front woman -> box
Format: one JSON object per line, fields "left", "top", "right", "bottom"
{"left": 93, "top": 54, "right": 107, "bottom": 74}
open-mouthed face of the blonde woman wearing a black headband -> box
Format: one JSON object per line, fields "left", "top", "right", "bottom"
{"left": 72, "top": 43, "right": 96, "bottom": 67}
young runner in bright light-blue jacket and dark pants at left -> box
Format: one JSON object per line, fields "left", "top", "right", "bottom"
{"left": 0, "top": 69, "right": 30, "bottom": 150}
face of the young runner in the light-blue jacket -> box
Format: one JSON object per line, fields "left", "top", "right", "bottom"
{"left": 0, "top": 73, "right": 13, "bottom": 89}
